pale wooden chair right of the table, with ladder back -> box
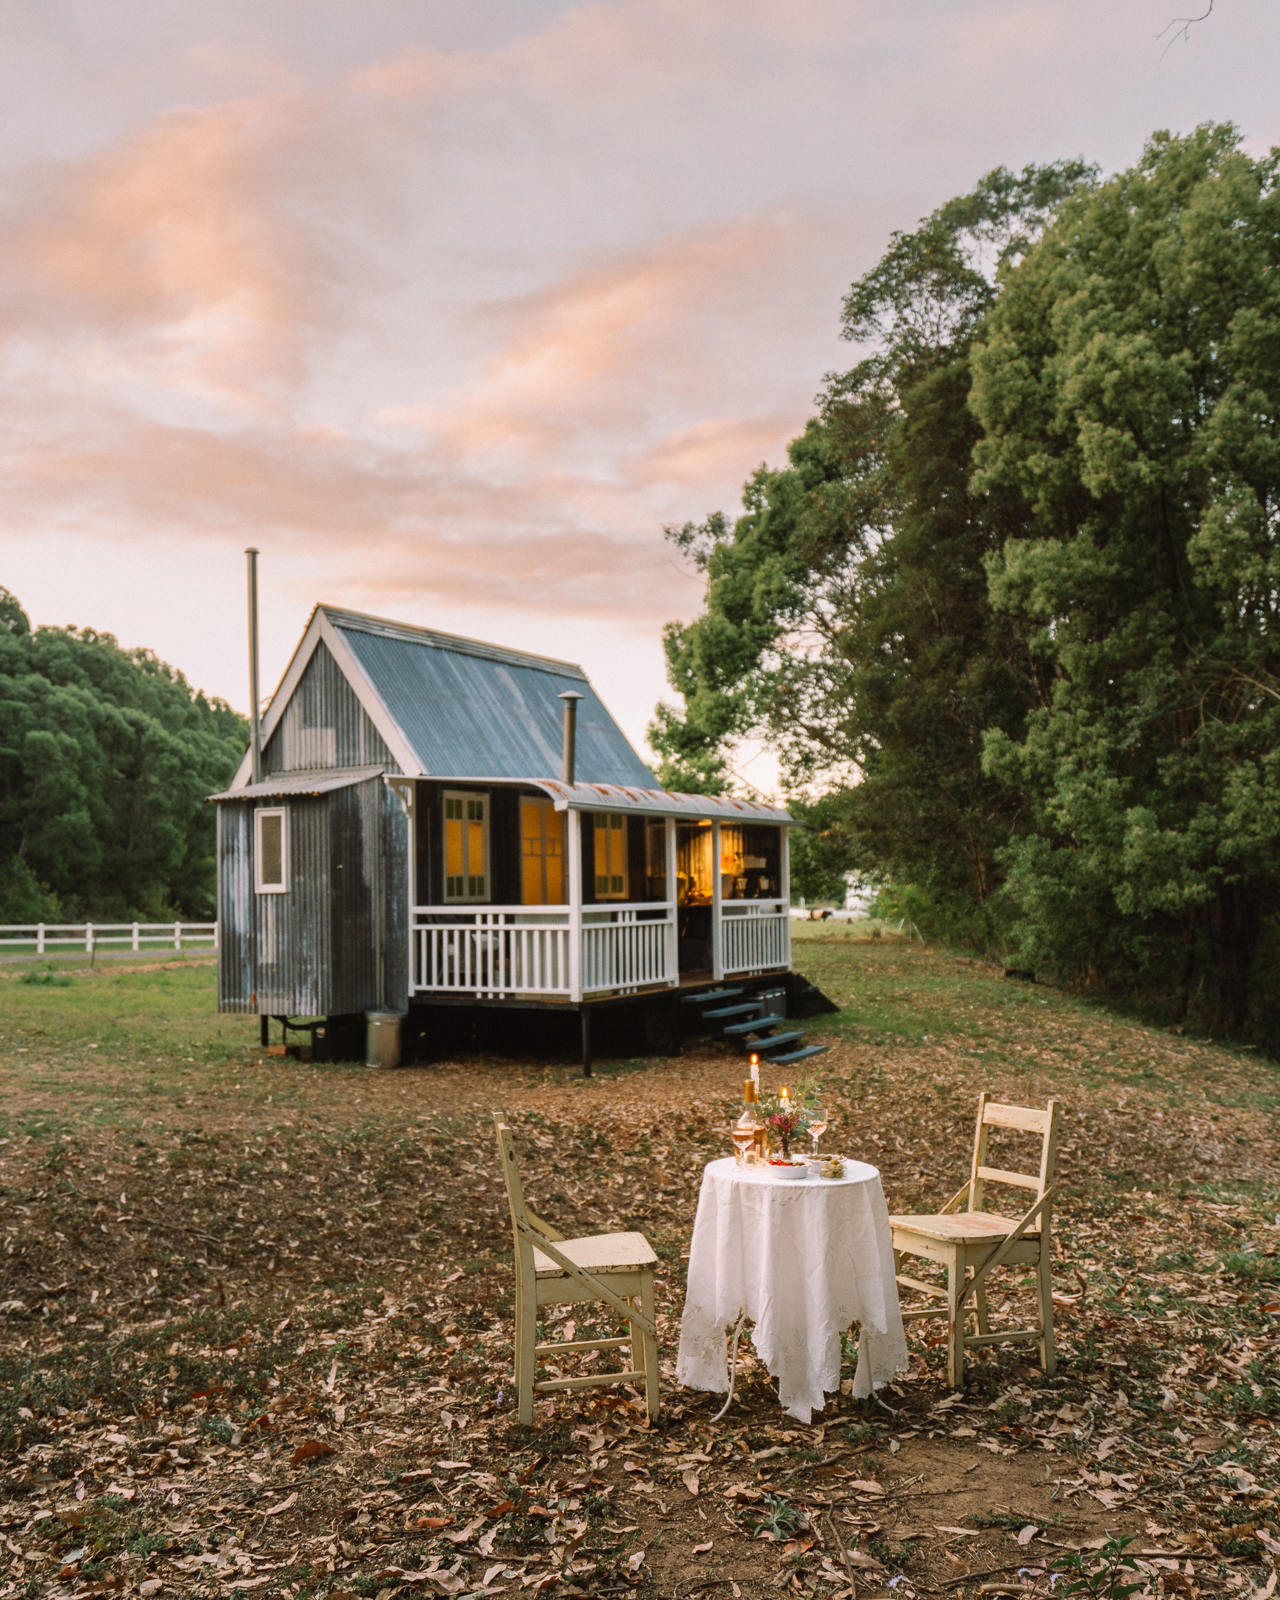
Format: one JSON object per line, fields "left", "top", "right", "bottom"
{"left": 890, "top": 1094, "right": 1058, "bottom": 1389}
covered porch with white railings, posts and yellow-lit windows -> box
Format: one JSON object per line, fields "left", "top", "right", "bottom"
{"left": 408, "top": 781, "right": 792, "bottom": 1005}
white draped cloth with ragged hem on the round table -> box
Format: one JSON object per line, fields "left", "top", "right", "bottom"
{"left": 675, "top": 1157, "right": 907, "bottom": 1422}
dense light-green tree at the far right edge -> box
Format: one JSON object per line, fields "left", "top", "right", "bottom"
{"left": 973, "top": 126, "right": 1280, "bottom": 1032}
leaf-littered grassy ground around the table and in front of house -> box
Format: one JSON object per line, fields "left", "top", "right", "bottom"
{"left": 0, "top": 926, "right": 1280, "bottom": 1600}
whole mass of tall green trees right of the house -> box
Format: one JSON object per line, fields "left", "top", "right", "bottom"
{"left": 653, "top": 126, "right": 1280, "bottom": 1030}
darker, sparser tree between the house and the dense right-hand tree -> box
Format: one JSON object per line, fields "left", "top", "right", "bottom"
{"left": 650, "top": 162, "right": 1093, "bottom": 938}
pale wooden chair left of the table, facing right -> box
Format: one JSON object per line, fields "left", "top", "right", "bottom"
{"left": 493, "top": 1112, "right": 658, "bottom": 1427}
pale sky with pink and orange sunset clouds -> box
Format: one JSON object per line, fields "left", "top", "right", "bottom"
{"left": 0, "top": 0, "right": 1280, "bottom": 786}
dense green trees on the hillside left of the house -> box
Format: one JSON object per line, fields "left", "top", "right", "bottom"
{"left": 0, "top": 589, "right": 248, "bottom": 922}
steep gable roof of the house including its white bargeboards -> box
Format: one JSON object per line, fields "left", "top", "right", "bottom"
{"left": 224, "top": 605, "right": 654, "bottom": 789}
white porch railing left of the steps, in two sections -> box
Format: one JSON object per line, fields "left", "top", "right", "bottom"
{"left": 411, "top": 902, "right": 678, "bottom": 1000}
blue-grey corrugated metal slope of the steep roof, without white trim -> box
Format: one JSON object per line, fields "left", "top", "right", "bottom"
{"left": 334, "top": 618, "right": 654, "bottom": 789}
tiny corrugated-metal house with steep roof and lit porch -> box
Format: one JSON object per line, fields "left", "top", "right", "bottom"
{"left": 213, "top": 606, "right": 809, "bottom": 1053}
